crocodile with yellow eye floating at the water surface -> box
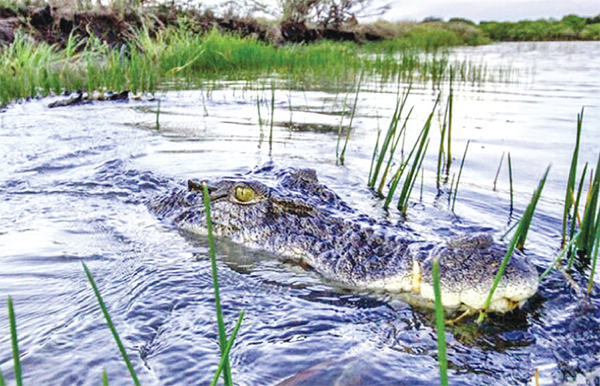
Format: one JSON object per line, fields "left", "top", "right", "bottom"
{"left": 151, "top": 166, "right": 538, "bottom": 313}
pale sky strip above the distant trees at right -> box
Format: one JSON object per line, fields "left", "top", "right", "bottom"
{"left": 383, "top": 0, "right": 600, "bottom": 22}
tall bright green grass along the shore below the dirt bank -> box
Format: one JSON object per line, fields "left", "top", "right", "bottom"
{"left": 0, "top": 25, "right": 502, "bottom": 105}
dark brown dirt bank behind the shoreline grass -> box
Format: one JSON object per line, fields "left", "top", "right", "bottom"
{"left": 0, "top": 6, "right": 384, "bottom": 47}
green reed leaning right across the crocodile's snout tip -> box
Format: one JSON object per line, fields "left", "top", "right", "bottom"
{"left": 477, "top": 167, "right": 550, "bottom": 324}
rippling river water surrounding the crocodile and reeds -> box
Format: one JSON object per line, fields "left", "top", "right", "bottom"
{"left": 0, "top": 43, "right": 600, "bottom": 386}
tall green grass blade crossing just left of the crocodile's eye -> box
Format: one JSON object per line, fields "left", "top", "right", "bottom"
{"left": 202, "top": 181, "right": 232, "bottom": 385}
